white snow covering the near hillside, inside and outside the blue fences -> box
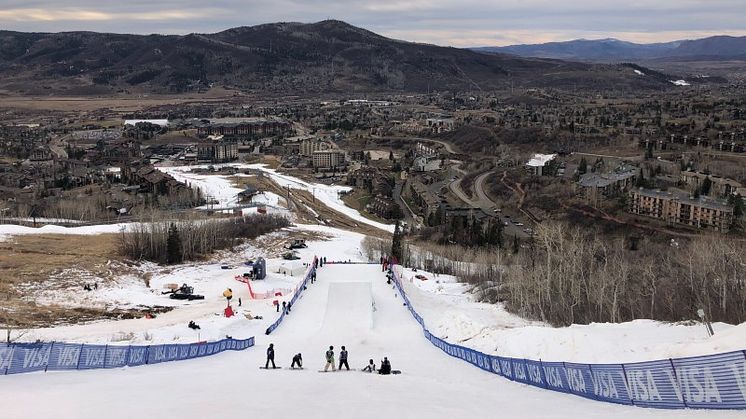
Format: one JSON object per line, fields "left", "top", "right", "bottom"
{"left": 0, "top": 220, "right": 746, "bottom": 418}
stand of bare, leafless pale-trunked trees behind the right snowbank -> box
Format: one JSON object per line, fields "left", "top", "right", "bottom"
{"left": 370, "top": 222, "right": 746, "bottom": 326}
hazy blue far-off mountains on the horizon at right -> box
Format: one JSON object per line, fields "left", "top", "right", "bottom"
{"left": 473, "top": 36, "right": 746, "bottom": 62}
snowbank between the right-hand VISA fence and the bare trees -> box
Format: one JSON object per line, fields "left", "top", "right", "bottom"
{"left": 402, "top": 269, "right": 746, "bottom": 363}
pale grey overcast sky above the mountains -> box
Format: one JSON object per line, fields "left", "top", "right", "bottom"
{"left": 0, "top": 0, "right": 746, "bottom": 47}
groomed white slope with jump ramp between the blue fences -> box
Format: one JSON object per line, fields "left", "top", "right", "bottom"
{"left": 0, "top": 264, "right": 743, "bottom": 419}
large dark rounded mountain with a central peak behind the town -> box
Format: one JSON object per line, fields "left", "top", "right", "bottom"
{"left": 0, "top": 20, "right": 670, "bottom": 94}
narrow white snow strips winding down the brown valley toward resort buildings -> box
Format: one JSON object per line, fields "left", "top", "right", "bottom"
{"left": 158, "top": 163, "right": 394, "bottom": 233}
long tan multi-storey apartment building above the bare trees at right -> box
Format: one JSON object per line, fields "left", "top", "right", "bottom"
{"left": 628, "top": 188, "right": 733, "bottom": 233}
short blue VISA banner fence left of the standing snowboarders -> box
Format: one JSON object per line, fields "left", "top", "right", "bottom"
{"left": 0, "top": 337, "right": 254, "bottom": 375}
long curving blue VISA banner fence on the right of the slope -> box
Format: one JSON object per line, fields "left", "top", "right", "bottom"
{"left": 386, "top": 270, "right": 746, "bottom": 409}
